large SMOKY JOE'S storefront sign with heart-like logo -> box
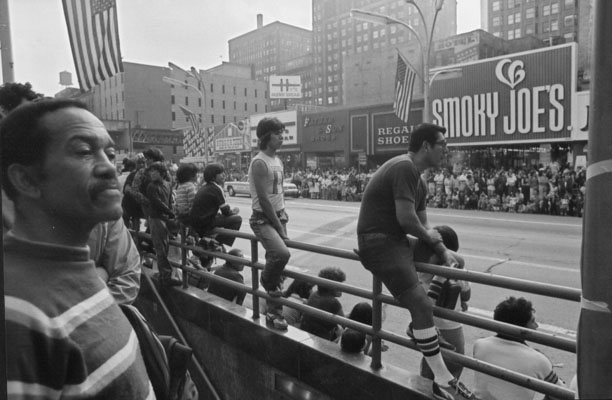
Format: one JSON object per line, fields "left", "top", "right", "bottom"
{"left": 431, "top": 44, "right": 575, "bottom": 143}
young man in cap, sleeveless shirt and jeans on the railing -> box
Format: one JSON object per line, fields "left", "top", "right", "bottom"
{"left": 248, "top": 118, "right": 291, "bottom": 330}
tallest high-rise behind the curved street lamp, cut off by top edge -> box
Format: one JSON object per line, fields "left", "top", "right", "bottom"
{"left": 312, "top": 0, "right": 457, "bottom": 106}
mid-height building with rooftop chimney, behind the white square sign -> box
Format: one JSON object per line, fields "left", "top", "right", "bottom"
{"left": 228, "top": 14, "right": 312, "bottom": 110}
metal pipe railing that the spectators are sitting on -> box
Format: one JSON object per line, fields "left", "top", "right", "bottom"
{"left": 138, "top": 228, "right": 581, "bottom": 400}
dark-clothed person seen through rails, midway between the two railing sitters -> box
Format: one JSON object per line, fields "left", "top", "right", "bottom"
{"left": 301, "top": 267, "right": 346, "bottom": 341}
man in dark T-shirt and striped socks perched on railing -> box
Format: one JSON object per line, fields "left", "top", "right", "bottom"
{"left": 357, "top": 123, "right": 473, "bottom": 399}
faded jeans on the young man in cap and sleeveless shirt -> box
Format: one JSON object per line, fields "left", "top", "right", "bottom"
{"left": 249, "top": 211, "right": 291, "bottom": 291}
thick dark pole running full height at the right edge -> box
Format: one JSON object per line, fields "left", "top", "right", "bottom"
{"left": 578, "top": 0, "right": 612, "bottom": 399}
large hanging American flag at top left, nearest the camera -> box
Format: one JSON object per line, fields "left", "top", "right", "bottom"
{"left": 62, "top": 0, "right": 123, "bottom": 91}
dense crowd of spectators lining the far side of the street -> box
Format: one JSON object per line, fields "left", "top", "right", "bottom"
{"left": 256, "top": 162, "right": 586, "bottom": 217}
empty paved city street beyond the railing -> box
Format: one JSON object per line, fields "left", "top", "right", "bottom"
{"left": 228, "top": 197, "right": 582, "bottom": 382}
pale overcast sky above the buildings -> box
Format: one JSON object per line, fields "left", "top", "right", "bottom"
{"left": 8, "top": 0, "right": 480, "bottom": 95}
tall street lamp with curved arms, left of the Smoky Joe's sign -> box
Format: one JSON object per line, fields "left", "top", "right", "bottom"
{"left": 351, "top": 0, "right": 444, "bottom": 121}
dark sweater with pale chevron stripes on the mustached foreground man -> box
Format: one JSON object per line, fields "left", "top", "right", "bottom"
{"left": 4, "top": 232, "right": 155, "bottom": 400}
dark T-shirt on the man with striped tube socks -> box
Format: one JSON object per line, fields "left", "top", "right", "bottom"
{"left": 357, "top": 154, "right": 427, "bottom": 237}
